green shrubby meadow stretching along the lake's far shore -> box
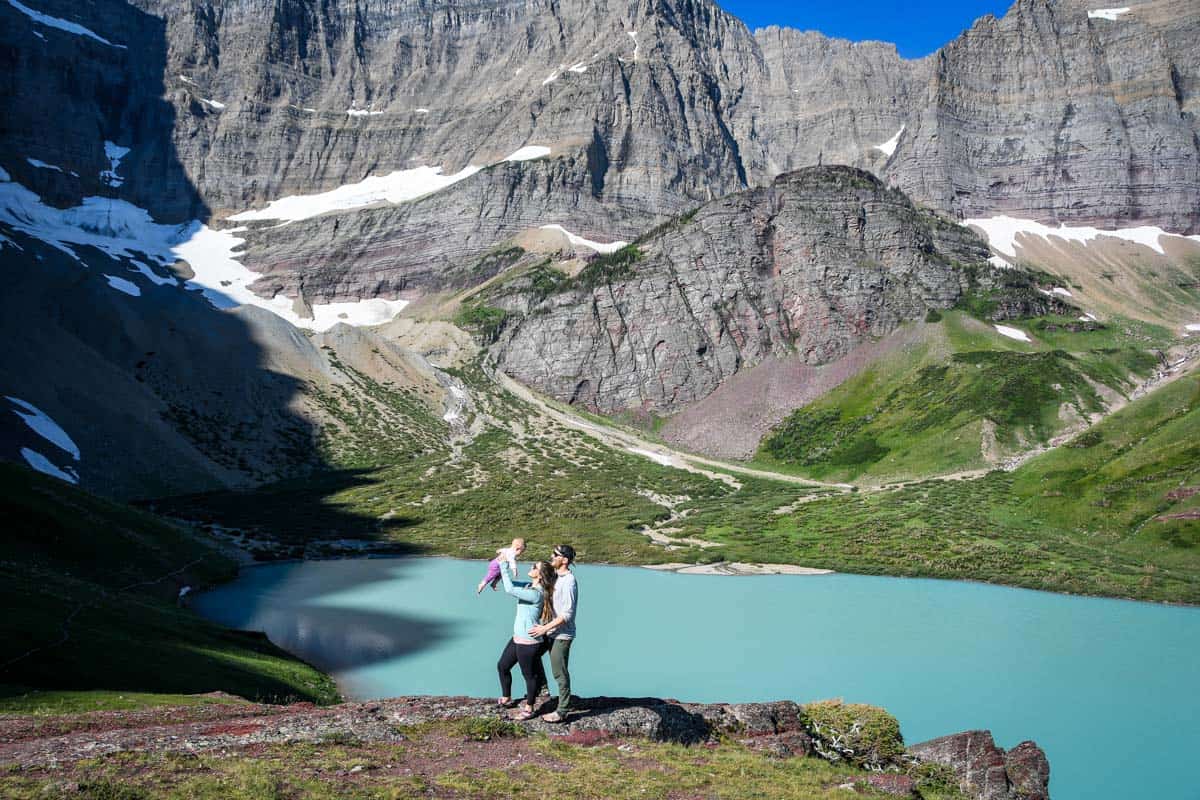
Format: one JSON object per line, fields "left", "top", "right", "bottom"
{"left": 161, "top": 347, "right": 1200, "bottom": 602}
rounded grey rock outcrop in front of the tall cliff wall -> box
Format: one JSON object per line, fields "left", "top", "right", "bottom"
{"left": 488, "top": 167, "right": 988, "bottom": 413}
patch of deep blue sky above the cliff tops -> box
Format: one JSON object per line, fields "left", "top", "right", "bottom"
{"left": 716, "top": 0, "right": 1013, "bottom": 59}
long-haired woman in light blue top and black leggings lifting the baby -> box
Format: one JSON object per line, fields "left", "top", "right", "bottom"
{"left": 496, "top": 561, "right": 558, "bottom": 720}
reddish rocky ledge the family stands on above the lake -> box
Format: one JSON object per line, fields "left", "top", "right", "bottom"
{"left": 0, "top": 696, "right": 1050, "bottom": 800}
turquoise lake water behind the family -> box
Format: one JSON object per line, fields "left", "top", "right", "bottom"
{"left": 196, "top": 559, "right": 1200, "bottom": 800}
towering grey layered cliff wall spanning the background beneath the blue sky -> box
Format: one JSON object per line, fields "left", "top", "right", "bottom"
{"left": 0, "top": 0, "right": 1200, "bottom": 301}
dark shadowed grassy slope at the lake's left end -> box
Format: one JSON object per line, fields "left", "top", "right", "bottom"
{"left": 0, "top": 464, "right": 337, "bottom": 708}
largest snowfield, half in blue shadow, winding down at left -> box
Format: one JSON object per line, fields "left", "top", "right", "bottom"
{"left": 0, "top": 170, "right": 408, "bottom": 331}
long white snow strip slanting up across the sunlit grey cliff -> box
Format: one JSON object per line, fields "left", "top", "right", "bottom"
{"left": 229, "top": 167, "right": 481, "bottom": 222}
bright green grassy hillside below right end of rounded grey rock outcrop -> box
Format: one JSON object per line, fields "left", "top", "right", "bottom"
{"left": 758, "top": 312, "right": 1169, "bottom": 481}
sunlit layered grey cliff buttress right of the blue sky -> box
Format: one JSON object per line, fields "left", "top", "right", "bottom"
{"left": 897, "top": 0, "right": 1200, "bottom": 233}
